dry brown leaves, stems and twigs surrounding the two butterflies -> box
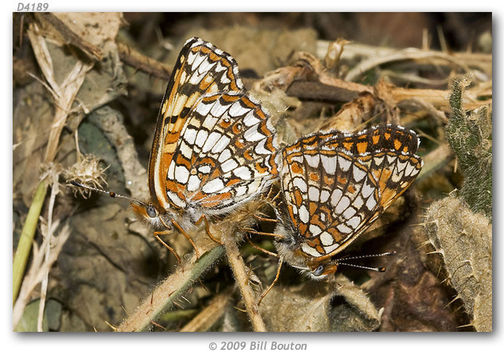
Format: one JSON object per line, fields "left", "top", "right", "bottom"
{"left": 13, "top": 13, "right": 492, "bottom": 331}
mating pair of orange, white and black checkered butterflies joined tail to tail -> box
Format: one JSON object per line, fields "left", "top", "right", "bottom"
{"left": 117, "top": 38, "right": 422, "bottom": 276}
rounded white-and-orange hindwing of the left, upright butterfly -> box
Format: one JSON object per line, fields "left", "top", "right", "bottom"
{"left": 167, "top": 92, "right": 278, "bottom": 215}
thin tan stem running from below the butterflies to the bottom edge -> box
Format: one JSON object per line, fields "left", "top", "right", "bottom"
{"left": 222, "top": 231, "right": 267, "bottom": 332}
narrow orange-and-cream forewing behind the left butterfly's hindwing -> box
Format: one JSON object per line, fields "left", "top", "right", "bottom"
{"left": 149, "top": 38, "right": 243, "bottom": 209}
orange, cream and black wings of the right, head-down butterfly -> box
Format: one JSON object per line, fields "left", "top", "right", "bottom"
{"left": 281, "top": 125, "right": 422, "bottom": 259}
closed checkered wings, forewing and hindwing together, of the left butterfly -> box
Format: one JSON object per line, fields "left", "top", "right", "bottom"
{"left": 149, "top": 38, "right": 278, "bottom": 214}
